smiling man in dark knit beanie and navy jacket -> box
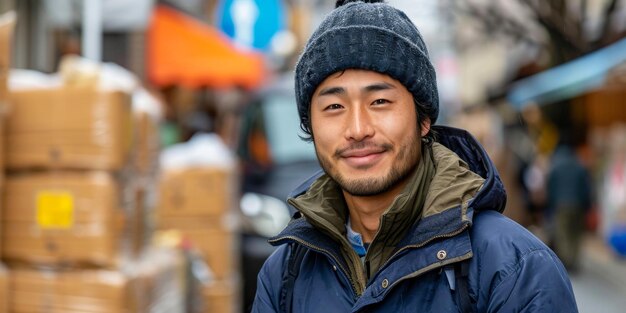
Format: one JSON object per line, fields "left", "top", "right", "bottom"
{"left": 253, "top": 1, "right": 577, "bottom": 313}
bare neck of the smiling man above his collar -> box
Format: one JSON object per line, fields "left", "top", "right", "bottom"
{"left": 343, "top": 181, "right": 408, "bottom": 243}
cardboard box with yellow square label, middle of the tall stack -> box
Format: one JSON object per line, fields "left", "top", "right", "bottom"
{"left": 0, "top": 172, "right": 132, "bottom": 267}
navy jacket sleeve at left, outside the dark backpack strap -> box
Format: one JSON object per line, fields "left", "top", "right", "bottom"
{"left": 252, "top": 245, "right": 288, "bottom": 313}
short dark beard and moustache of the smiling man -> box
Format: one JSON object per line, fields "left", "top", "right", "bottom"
{"left": 315, "top": 134, "right": 421, "bottom": 197}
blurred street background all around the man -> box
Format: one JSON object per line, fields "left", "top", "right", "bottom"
{"left": 0, "top": 0, "right": 626, "bottom": 313}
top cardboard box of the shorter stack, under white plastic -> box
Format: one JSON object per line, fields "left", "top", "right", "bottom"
{"left": 157, "top": 168, "right": 236, "bottom": 217}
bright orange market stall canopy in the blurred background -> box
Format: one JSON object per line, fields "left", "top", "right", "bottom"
{"left": 147, "top": 5, "right": 265, "bottom": 89}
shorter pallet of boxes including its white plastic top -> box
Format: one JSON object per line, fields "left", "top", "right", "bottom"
{"left": 156, "top": 134, "right": 238, "bottom": 279}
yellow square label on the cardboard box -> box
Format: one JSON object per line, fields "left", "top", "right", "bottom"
{"left": 37, "top": 191, "right": 74, "bottom": 228}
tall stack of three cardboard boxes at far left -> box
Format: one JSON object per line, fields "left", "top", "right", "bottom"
{"left": 0, "top": 74, "right": 173, "bottom": 313}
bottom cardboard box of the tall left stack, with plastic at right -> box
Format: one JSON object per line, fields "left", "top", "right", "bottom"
{"left": 7, "top": 250, "right": 184, "bottom": 313}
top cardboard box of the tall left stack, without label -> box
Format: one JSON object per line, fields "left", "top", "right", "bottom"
{"left": 6, "top": 88, "right": 134, "bottom": 170}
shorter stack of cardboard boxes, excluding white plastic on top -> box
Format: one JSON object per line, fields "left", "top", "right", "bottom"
{"left": 157, "top": 167, "right": 240, "bottom": 313}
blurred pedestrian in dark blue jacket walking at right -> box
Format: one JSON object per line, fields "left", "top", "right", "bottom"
{"left": 546, "top": 135, "right": 592, "bottom": 271}
